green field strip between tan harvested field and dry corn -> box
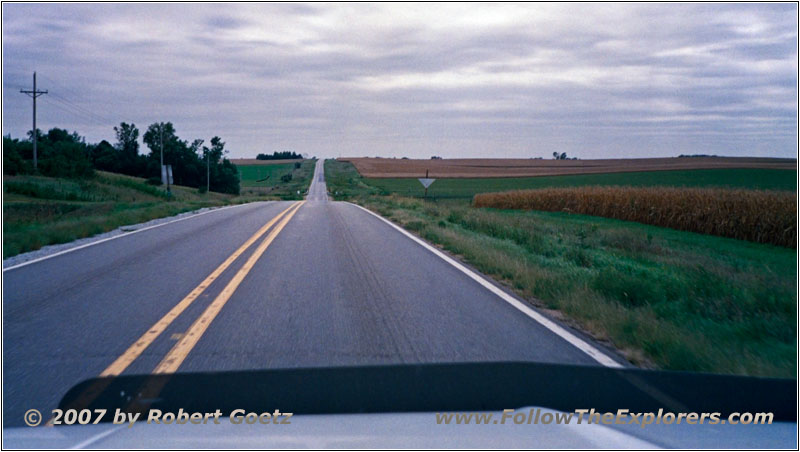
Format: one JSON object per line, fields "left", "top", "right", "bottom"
{"left": 364, "top": 169, "right": 797, "bottom": 198}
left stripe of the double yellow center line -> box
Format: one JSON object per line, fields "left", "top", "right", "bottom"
{"left": 100, "top": 203, "right": 299, "bottom": 377}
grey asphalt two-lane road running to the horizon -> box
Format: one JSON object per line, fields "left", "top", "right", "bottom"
{"left": 3, "top": 162, "right": 620, "bottom": 427}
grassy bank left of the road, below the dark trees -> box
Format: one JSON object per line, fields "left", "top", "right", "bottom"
{"left": 3, "top": 172, "right": 234, "bottom": 258}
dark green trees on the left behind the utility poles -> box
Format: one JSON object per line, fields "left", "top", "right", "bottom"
{"left": 3, "top": 122, "right": 239, "bottom": 194}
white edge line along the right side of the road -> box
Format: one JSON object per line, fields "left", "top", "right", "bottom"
{"left": 347, "top": 202, "right": 623, "bottom": 368}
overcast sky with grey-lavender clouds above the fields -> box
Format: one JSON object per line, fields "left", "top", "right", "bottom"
{"left": 2, "top": 3, "right": 798, "bottom": 158}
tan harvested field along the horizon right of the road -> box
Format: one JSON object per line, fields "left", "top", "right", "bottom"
{"left": 342, "top": 157, "right": 797, "bottom": 178}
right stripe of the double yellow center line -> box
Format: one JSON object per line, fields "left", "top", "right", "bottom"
{"left": 153, "top": 201, "right": 305, "bottom": 374}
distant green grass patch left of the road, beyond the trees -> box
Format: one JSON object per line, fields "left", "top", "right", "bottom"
{"left": 237, "top": 160, "right": 314, "bottom": 200}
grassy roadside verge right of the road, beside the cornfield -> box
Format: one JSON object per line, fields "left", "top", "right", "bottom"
{"left": 326, "top": 161, "right": 797, "bottom": 377}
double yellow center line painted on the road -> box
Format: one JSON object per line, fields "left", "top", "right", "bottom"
{"left": 100, "top": 201, "right": 305, "bottom": 377}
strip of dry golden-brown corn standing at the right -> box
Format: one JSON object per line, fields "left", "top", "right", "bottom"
{"left": 472, "top": 187, "right": 797, "bottom": 248}
